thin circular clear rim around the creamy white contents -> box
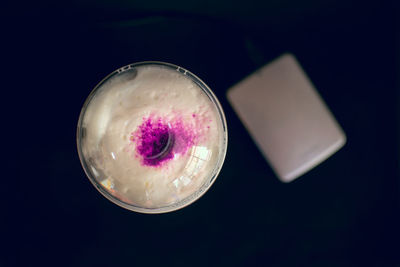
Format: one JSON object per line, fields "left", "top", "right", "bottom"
{"left": 76, "top": 61, "right": 228, "bottom": 214}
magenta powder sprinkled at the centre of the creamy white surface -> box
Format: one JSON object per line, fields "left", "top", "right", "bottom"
{"left": 131, "top": 117, "right": 196, "bottom": 167}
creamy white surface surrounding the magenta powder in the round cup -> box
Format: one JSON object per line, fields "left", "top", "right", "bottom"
{"left": 82, "top": 66, "right": 224, "bottom": 208}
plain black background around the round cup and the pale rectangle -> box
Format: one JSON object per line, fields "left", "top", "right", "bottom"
{"left": 0, "top": 0, "right": 400, "bottom": 266}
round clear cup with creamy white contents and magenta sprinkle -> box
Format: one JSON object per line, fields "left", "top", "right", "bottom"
{"left": 77, "top": 61, "right": 228, "bottom": 213}
